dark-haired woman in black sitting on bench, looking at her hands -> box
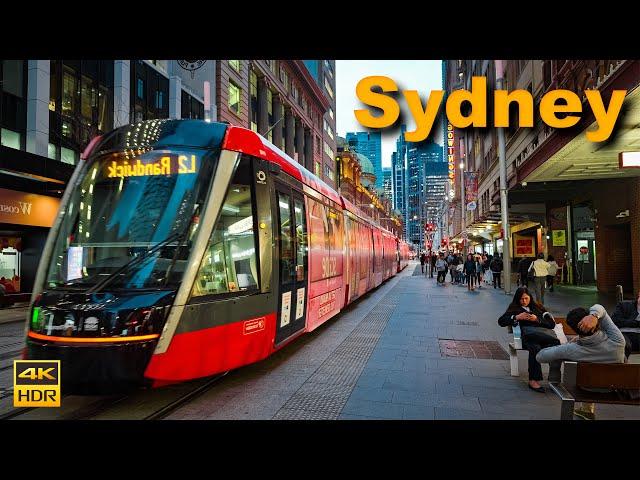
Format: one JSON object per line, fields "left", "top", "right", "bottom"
{"left": 498, "top": 287, "right": 560, "bottom": 393}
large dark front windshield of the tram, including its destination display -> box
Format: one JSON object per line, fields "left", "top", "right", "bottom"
{"left": 47, "top": 148, "right": 219, "bottom": 290}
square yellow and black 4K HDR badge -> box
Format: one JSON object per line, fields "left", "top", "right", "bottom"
{"left": 13, "top": 360, "right": 60, "bottom": 407}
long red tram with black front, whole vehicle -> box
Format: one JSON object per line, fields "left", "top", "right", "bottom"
{"left": 24, "top": 120, "right": 409, "bottom": 393}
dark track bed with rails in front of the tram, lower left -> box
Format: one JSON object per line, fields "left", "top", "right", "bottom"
{"left": 0, "top": 372, "right": 226, "bottom": 420}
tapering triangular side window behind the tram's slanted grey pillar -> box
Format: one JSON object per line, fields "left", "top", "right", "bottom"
{"left": 193, "top": 157, "right": 258, "bottom": 296}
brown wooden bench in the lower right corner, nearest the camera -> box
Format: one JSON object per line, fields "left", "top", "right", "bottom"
{"left": 549, "top": 362, "right": 640, "bottom": 420}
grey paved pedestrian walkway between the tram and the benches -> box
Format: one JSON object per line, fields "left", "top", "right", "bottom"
{"left": 169, "top": 263, "right": 640, "bottom": 420}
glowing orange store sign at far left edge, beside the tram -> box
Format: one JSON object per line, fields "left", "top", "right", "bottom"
{"left": 0, "top": 188, "right": 60, "bottom": 227}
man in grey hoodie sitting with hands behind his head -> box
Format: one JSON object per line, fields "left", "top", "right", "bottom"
{"left": 536, "top": 304, "right": 625, "bottom": 420}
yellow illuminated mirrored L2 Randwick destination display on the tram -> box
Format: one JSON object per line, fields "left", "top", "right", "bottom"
{"left": 105, "top": 155, "right": 197, "bottom": 178}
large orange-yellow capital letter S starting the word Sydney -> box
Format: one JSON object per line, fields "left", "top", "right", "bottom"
{"left": 354, "top": 76, "right": 400, "bottom": 128}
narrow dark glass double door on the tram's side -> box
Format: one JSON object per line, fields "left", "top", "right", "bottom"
{"left": 276, "top": 185, "right": 308, "bottom": 344}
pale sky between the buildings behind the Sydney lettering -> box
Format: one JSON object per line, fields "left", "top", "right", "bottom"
{"left": 336, "top": 60, "right": 442, "bottom": 167}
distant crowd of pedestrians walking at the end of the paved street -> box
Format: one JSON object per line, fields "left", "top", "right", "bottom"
{"left": 420, "top": 252, "right": 503, "bottom": 291}
